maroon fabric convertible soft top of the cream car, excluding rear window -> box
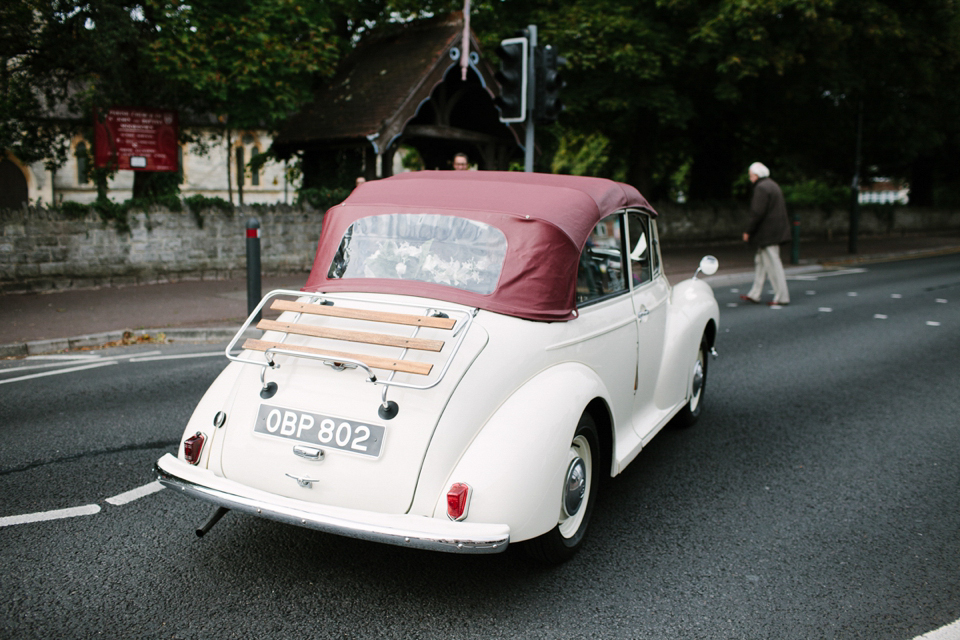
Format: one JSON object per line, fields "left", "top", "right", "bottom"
{"left": 303, "top": 171, "right": 655, "bottom": 321}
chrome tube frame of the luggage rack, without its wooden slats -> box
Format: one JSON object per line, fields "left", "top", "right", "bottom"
{"left": 225, "top": 289, "right": 479, "bottom": 419}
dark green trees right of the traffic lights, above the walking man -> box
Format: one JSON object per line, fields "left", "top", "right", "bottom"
{"left": 475, "top": 0, "right": 960, "bottom": 199}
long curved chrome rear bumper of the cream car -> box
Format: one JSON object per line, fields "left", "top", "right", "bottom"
{"left": 156, "top": 453, "right": 510, "bottom": 554}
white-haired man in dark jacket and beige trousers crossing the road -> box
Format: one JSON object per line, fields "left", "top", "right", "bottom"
{"left": 740, "top": 162, "right": 790, "bottom": 306}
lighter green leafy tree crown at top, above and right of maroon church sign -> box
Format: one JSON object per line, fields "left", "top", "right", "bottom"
{"left": 147, "top": 0, "right": 339, "bottom": 128}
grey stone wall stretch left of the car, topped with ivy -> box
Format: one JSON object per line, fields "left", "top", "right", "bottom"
{"left": 0, "top": 206, "right": 323, "bottom": 293}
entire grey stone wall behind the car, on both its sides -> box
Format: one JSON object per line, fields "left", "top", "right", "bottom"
{"left": 0, "top": 205, "right": 960, "bottom": 293}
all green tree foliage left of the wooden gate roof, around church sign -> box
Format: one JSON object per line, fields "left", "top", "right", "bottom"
{"left": 0, "top": 0, "right": 339, "bottom": 201}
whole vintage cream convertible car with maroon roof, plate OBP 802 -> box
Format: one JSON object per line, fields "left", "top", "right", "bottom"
{"left": 157, "top": 172, "right": 718, "bottom": 562}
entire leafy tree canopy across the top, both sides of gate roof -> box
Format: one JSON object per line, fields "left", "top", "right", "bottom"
{"left": 0, "top": 0, "right": 960, "bottom": 202}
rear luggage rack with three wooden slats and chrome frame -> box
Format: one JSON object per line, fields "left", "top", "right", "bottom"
{"left": 226, "top": 289, "right": 477, "bottom": 420}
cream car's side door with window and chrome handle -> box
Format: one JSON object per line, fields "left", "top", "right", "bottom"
{"left": 627, "top": 210, "right": 670, "bottom": 443}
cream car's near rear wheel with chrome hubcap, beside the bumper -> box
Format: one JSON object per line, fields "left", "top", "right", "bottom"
{"left": 525, "top": 413, "right": 600, "bottom": 564}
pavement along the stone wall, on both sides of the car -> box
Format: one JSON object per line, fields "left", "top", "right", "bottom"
{"left": 0, "top": 231, "right": 960, "bottom": 358}
